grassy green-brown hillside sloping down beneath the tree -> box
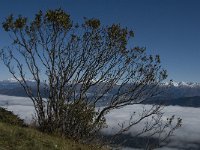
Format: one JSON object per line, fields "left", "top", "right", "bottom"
{"left": 0, "top": 122, "right": 105, "bottom": 150}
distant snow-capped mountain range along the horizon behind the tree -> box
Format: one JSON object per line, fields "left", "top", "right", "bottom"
{"left": 0, "top": 79, "right": 200, "bottom": 104}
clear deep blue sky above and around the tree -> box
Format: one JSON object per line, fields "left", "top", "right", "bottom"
{"left": 0, "top": 0, "right": 200, "bottom": 82}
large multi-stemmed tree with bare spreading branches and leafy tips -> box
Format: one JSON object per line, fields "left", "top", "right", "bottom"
{"left": 2, "top": 9, "right": 180, "bottom": 147}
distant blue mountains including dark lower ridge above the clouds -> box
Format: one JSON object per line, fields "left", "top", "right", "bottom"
{"left": 0, "top": 79, "right": 200, "bottom": 107}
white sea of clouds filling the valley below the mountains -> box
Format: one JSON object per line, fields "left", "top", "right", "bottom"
{"left": 0, "top": 95, "right": 200, "bottom": 150}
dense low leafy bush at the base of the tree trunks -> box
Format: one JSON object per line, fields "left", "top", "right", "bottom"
{"left": 38, "top": 100, "right": 106, "bottom": 142}
